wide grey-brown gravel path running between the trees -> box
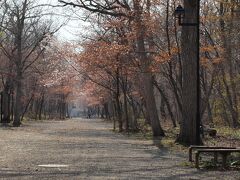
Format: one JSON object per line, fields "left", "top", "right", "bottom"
{"left": 0, "top": 118, "right": 240, "bottom": 180}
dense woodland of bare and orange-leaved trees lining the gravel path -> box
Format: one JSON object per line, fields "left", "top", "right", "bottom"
{"left": 0, "top": 0, "right": 240, "bottom": 144}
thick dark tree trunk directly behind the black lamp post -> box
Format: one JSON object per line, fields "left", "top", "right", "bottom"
{"left": 177, "top": 0, "right": 200, "bottom": 145}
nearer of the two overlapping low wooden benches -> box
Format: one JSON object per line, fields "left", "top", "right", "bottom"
{"left": 195, "top": 148, "right": 240, "bottom": 168}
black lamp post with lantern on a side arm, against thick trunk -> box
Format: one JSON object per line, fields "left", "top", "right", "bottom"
{"left": 174, "top": 3, "right": 201, "bottom": 145}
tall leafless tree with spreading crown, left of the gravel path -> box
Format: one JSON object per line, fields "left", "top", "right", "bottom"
{"left": 0, "top": 0, "right": 58, "bottom": 126}
